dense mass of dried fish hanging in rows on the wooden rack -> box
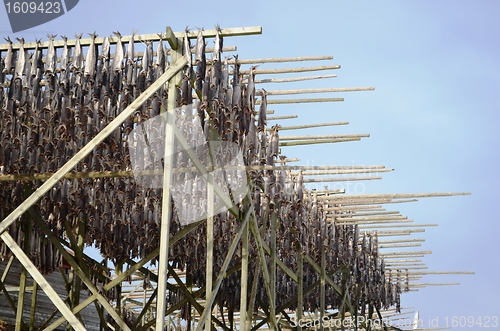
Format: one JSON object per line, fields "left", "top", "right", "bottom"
{"left": 0, "top": 30, "right": 402, "bottom": 311}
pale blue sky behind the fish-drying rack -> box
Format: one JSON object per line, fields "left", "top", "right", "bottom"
{"left": 0, "top": 0, "right": 500, "bottom": 330}
